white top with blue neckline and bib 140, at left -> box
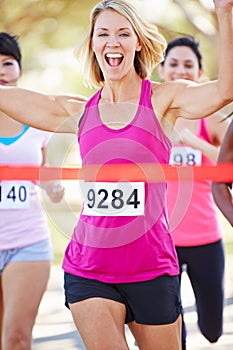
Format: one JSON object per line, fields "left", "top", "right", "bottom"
{"left": 0, "top": 126, "right": 51, "bottom": 250}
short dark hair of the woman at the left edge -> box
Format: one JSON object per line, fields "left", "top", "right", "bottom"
{"left": 0, "top": 32, "right": 21, "bottom": 68}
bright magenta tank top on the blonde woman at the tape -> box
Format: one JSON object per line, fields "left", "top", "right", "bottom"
{"left": 63, "top": 80, "right": 179, "bottom": 283}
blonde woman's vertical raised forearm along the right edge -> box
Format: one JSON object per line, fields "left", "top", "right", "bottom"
{"left": 215, "top": 1, "right": 233, "bottom": 102}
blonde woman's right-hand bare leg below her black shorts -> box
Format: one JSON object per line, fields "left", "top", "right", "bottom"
{"left": 128, "top": 316, "right": 182, "bottom": 350}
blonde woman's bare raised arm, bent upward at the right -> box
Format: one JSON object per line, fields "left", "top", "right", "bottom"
{"left": 166, "top": 0, "right": 233, "bottom": 119}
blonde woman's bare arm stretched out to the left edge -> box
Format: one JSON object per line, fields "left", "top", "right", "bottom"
{"left": 0, "top": 86, "right": 86, "bottom": 133}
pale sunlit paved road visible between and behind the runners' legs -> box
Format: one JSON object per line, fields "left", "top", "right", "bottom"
{"left": 33, "top": 258, "right": 233, "bottom": 350}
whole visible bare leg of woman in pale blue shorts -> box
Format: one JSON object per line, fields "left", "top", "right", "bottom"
{"left": 2, "top": 261, "right": 50, "bottom": 350}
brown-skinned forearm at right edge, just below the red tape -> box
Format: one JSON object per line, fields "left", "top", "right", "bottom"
{"left": 212, "top": 183, "right": 233, "bottom": 226}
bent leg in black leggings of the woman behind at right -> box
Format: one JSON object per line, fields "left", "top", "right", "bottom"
{"left": 187, "top": 241, "right": 224, "bottom": 340}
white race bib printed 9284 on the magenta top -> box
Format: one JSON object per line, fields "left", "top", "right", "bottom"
{"left": 80, "top": 181, "right": 145, "bottom": 216}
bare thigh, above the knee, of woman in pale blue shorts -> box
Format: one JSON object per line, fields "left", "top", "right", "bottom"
{"left": 2, "top": 260, "right": 50, "bottom": 330}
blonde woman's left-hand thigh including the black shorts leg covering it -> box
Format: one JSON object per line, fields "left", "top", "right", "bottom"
{"left": 64, "top": 273, "right": 128, "bottom": 350}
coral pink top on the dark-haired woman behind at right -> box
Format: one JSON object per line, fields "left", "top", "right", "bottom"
{"left": 167, "top": 119, "right": 222, "bottom": 247}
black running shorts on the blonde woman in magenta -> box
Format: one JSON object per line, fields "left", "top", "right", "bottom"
{"left": 64, "top": 273, "right": 182, "bottom": 325}
